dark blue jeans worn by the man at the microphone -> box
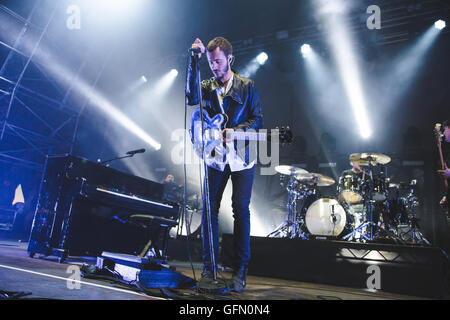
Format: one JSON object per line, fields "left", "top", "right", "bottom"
{"left": 202, "top": 165, "right": 255, "bottom": 269}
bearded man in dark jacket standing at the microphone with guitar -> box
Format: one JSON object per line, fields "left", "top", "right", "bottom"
{"left": 186, "top": 37, "right": 263, "bottom": 292}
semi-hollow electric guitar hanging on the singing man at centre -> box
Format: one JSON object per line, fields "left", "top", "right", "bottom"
{"left": 190, "top": 108, "right": 293, "bottom": 165}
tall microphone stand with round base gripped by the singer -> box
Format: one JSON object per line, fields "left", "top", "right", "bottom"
{"left": 192, "top": 53, "right": 228, "bottom": 294}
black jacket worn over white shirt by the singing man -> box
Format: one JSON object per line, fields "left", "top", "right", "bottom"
{"left": 186, "top": 59, "right": 263, "bottom": 131}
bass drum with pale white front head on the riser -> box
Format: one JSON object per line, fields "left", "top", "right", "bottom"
{"left": 305, "top": 198, "right": 347, "bottom": 237}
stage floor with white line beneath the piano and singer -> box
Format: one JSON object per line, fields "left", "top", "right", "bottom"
{"left": 0, "top": 240, "right": 436, "bottom": 301}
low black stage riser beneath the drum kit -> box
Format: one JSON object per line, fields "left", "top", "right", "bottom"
{"left": 221, "top": 234, "right": 446, "bottom": 298}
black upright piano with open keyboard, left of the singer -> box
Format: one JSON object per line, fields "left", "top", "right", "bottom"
{"left": 28, "top": 155, "right": 179, "bottom": 262}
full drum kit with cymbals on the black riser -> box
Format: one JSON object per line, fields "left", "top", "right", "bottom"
{"left": 268, "top": 153, "right": 429, "bottom": 245}
